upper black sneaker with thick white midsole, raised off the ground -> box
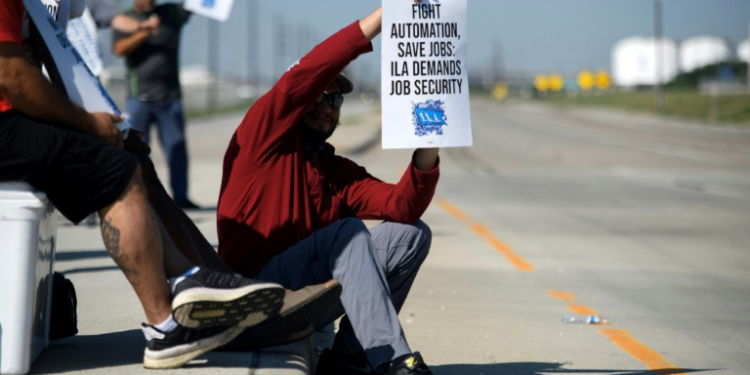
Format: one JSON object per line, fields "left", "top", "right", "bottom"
{"left": 172, "top": 268, "right": 285, "bottom": 329}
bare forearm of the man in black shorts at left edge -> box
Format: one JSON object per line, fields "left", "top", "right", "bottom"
{"left": 0, "top": 43, "right": 122, "bottom": 146}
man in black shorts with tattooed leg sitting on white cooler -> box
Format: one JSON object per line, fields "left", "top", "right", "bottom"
{"left": 0, "top": 0, "right": 336, "bottom": 368}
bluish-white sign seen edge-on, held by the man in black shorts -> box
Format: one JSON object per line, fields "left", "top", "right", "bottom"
{"left": 23, "top": 0, "right": 130, "bottom": 135}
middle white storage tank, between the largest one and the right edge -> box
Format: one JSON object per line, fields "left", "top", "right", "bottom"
{"left": 680, "top": 36, "right": 732, "bottom": 73}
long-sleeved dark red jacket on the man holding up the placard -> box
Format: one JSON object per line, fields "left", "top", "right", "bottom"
{"left": 218, "top": 22, "right": 439, "bottom": 276}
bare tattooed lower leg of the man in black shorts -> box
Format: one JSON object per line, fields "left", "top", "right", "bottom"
{"left": 99, "top": 168, "right": 193, "bottom": 324}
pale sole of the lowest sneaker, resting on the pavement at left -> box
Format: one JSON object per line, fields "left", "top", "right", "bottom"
{"left": 143, "top": 327, "right": 244, "bottom": 369}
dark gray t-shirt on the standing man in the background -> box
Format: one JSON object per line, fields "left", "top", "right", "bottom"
{"left": 113, "top": 4, "right": 192, "bottom": 103}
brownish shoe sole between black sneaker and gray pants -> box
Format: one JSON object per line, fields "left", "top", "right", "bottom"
{"left": 222, "top": 281, "right": 342, "bottom": 351}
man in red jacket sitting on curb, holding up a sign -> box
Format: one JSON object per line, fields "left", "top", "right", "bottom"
{"left": 218, "top": 3, "right": 439, "bottom": 375}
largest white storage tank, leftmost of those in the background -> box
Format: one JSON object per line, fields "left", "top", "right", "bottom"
{"left": 612, "top": 37, "right": 678, "bottom": 87}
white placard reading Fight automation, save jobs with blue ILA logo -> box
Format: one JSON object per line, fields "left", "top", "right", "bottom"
{"left": 381, "top": 0, "right": 472, "bottom": 149}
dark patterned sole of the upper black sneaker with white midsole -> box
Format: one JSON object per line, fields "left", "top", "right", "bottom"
{"left": 172, "top": 283, "right": 285, "bottom": 329}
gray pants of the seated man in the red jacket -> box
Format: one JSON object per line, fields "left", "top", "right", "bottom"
{"left": 258, "top": 218, "right": 432, "bottom": 367}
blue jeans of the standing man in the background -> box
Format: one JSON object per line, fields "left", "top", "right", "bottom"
{"left": 127, "top": 98, "right": 188, "bottom": 203}
